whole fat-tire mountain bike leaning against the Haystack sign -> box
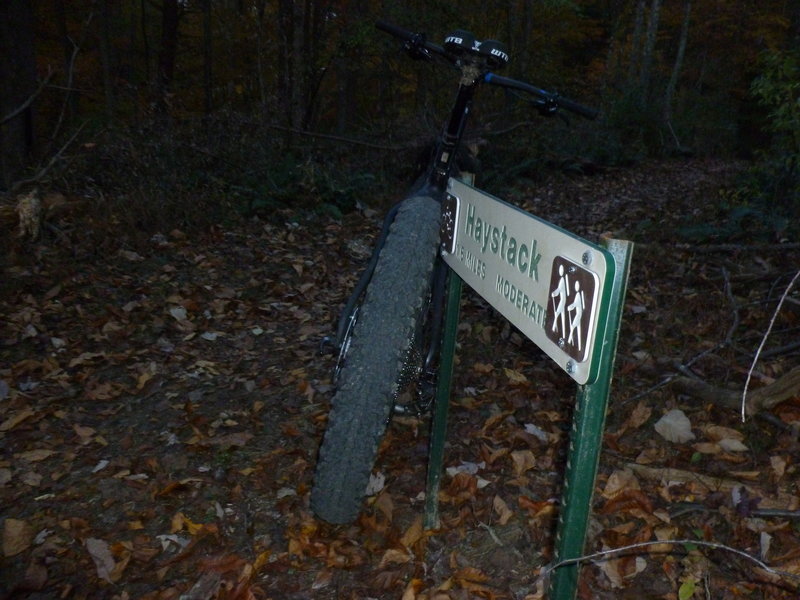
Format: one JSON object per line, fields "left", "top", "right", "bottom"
{"left": 311, "top": 21, "right": 598, "bottom": 524}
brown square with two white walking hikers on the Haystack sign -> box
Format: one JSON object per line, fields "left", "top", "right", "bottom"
{"left": 545, "top": 256, "right": 597, "bottom": 361}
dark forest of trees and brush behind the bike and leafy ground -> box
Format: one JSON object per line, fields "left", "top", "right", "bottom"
{"left": 0, "top": 0, "right": 800, "bottom": 238}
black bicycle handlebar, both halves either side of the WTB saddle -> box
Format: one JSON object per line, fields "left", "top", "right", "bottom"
{"left": 375, "top": 21, "right": 600, "bottom": 119}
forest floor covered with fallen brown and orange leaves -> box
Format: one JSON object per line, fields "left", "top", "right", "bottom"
{"left": 0, "top": 160, "right": 800, "bottom": 600}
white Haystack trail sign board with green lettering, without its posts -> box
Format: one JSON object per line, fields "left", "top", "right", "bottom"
{"left": 442, "top": 179, "right": 615, "bottom": 384}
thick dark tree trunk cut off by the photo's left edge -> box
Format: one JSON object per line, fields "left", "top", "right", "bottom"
{"left": 0, "top": 0, "right": 36, "bottom": 188}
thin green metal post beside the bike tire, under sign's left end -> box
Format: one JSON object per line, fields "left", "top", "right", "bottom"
{"left": 425, "top": 271, "right": 461, "bottom": 529}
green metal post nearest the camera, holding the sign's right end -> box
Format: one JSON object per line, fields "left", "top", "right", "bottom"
{"left": 548, "top": 239, "right": 633, "bottom": 600}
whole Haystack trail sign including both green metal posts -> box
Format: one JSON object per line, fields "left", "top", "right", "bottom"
{"left": 425, "top": 180, "right": 633, "bottom": 600}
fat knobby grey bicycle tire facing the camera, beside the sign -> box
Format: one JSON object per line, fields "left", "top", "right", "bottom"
{"left": 311, "top": 196, "right": 440, "bottom": 523}
